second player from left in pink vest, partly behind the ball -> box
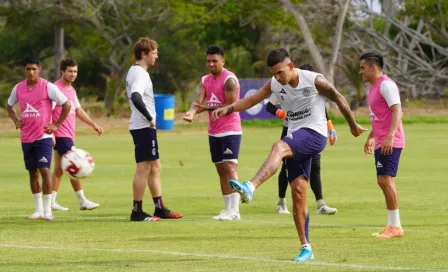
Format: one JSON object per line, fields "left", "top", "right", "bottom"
{"left": 51, "top": 59, "right": 103, "bottom": 211}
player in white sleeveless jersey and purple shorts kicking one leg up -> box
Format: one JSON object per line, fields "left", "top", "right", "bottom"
{"left": 213, "top": 48, "right": 364, "bottom": 262}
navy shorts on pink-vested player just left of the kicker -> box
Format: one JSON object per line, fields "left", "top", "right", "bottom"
{"left": 208, "top": 135, "right": 241, "bottom": 164}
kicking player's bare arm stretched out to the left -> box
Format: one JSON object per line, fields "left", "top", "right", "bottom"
{"left": 212, "top": 79, "right": 272, "bottom": 120}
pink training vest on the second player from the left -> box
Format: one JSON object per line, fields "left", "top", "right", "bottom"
{"left": 52, "top": 80, "right": 81, "bottom": 140}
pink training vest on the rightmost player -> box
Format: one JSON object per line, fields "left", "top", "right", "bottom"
{"left": 368, "top": 75, "right": 405, "bottom": 150}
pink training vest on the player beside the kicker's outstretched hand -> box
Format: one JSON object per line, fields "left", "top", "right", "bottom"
{"left": 202, "top": 69, "right": 242, "bottom": 137}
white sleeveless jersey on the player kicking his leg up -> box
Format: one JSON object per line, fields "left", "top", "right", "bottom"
{"left": 271, "top": 69, "right": 327, "bottom": 137}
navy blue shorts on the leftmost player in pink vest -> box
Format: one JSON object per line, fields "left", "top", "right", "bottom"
{"left": 22, "top": 138, "right": 53, "bottom": 170}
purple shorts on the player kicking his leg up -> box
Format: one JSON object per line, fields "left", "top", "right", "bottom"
{"left": 282, "top": 128, "right": 327, "bottom": 183}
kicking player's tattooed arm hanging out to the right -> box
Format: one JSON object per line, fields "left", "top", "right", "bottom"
{"left": 314, "top": 75, "right": 366, "bottom": 137}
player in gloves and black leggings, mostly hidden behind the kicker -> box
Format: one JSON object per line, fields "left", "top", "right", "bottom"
{"left": 266, "top": 64, "right": 338, "bottom": 214}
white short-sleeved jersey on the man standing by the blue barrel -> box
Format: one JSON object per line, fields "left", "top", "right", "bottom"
{"left": 126, "top": 64, "right": 156, "bottom": 130}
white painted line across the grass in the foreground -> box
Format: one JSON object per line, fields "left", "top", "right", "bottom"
{"left": 0, "top": 244, "right": 448, "bottom": 271}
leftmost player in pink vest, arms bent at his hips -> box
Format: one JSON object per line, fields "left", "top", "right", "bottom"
{"left": 8, "top": 57, "right": 70, "bottom": 221}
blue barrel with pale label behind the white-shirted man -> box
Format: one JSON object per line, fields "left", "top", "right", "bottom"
{"left": 154, "top": 94, "right": 174, "bottom": 130}
